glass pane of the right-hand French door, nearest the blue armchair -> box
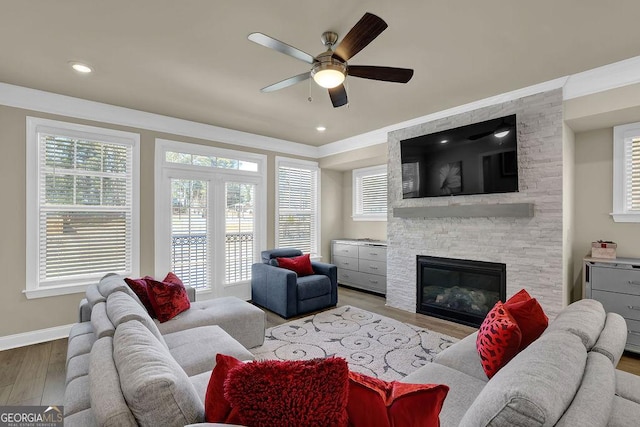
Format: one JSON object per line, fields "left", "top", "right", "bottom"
{"left": 225, "top": 182, "right": 255, "bottom": 283}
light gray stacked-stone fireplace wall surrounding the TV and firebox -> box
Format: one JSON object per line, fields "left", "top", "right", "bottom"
{"left": 387, "top": 89, "right": 573, "bottom": 318}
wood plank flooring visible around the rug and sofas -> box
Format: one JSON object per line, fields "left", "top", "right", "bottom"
{"left": 0, "top": 287, "right": 640, "bottom": 405}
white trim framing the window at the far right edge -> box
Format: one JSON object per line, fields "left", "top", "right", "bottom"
{"left": 610, "top": 123, "right": 640, "bottom": 222}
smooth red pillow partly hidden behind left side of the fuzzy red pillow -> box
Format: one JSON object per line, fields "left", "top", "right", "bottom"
{"left": 204, "top": 353, "right": 243, "bottom": 424}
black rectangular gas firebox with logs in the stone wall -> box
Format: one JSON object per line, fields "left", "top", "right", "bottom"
{"left": 416, "top": 255, "right": 507, "bottom": 327}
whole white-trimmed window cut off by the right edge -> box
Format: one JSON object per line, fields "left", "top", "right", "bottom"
{"left": 611, "top": 123, "right": 640, "bottom": 222}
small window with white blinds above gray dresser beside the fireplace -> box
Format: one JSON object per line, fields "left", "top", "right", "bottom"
{"left": 352, "top": 165, "right": 387, "bottom": 221}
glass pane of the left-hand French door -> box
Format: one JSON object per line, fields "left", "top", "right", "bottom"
{"left": 171, "top": 179, "right": 211, "bottom": 289}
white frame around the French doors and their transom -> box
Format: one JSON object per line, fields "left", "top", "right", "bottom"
{"left": 154, "top": 138, "right": 267, "bottom": 299}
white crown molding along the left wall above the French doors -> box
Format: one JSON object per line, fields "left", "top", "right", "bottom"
{"left": 0, "top": 83, "right": 318, "bottom": 158}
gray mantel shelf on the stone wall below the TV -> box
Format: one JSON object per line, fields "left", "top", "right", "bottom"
{"left": 393, "top": 203, "right": 533, "bottom": 218}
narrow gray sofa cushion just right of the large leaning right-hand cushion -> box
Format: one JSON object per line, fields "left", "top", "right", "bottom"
{"left": 556, "top": 352, "right": 616, "bottom": 427}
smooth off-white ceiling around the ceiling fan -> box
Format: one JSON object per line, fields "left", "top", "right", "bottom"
{"left": 0, "top": 0, "right": 640, "bottom": 146}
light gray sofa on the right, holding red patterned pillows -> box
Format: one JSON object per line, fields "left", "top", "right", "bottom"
{"left": 402, "top": 299, "right": 640, "bottom": 427}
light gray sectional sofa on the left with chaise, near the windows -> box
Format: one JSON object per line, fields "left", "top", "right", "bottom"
{"left": 64, "top": 275, "right": 265, "bottom": 427}
